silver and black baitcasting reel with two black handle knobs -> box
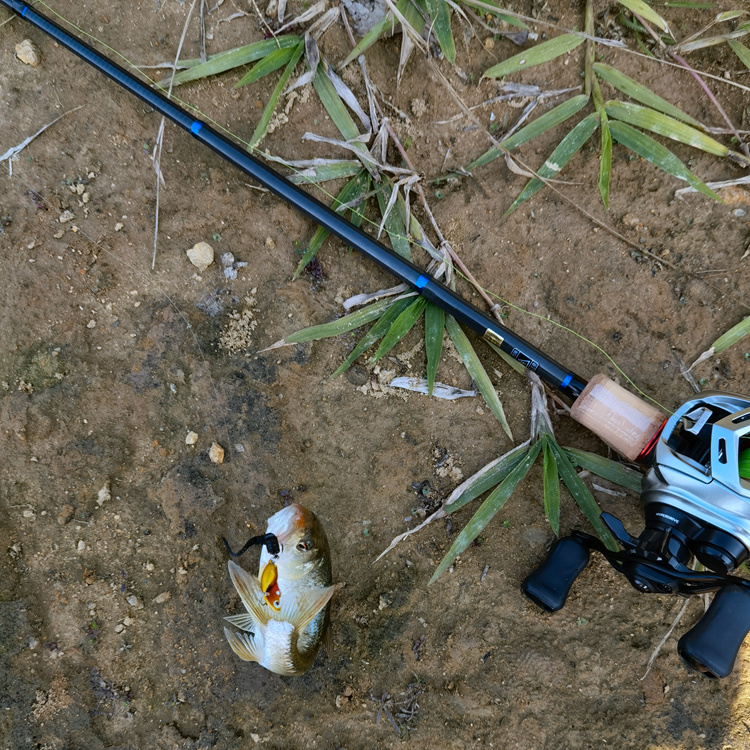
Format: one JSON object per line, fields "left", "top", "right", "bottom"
{"left": 523, "top": 391, "right": 750, "bottom": 677}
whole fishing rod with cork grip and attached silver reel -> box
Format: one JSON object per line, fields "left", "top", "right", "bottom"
{"left": 0, "top": 0, "right": 750, "bottom": 677}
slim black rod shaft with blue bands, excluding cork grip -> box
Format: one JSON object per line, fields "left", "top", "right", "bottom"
{"left": 0, "top": 0, "right": 585, "bottom": 398}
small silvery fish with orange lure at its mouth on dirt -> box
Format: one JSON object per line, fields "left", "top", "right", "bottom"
{"left": 224, "top": 503, "right": 336, "bottom": 676}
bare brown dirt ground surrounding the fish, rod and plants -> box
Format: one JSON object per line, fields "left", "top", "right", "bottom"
{"left": 0, "top": 0, "right": 750, "bottom": 750}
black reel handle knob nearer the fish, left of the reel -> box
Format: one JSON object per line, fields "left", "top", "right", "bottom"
{"left": 521, "top": 536, "right": 591, "bottom": 612}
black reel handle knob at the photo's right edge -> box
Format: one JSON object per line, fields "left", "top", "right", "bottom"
{"left": 677, "top": 584, "right": 750, "bottom": 678}
